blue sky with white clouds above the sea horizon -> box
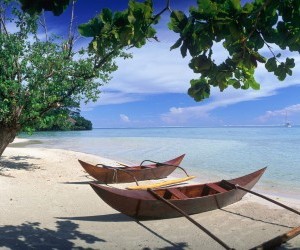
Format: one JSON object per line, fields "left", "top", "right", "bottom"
{"left": 46, "top": 0, "right": 300, "bottom": 128}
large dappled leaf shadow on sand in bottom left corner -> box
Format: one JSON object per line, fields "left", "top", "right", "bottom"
{"left": 0, "top": 221, "right": 105, "bottom": 250}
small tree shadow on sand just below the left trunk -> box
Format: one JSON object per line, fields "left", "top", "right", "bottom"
{"left": 0, "top": 156, "right": 40, "bottom": 175}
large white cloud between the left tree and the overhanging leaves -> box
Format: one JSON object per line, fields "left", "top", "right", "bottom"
{"left": 104, "top": 42, "right": 193, "bottom": 94}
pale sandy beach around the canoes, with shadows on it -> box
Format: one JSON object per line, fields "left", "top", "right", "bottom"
{"left": 0, "top": 141, "right": 300, "bottom": 249}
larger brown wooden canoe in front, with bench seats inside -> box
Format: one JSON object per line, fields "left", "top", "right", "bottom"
{"left": 90, "top": 168, "right": 266, "bottom": 219}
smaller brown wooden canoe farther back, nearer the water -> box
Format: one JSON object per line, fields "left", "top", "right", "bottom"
{"left": 78, "top": 154, "right": 185, "bottom": 184}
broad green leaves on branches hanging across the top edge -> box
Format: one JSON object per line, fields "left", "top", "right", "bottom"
{"left": 20, "top": 0, "right": 300, "bottom": 101}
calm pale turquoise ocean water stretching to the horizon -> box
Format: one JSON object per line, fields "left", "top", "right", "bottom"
{"left": 20, "top": 127, "right": 300, "bottom": 199}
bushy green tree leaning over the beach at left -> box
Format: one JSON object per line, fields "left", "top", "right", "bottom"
{"left": 0, "top": 0, "right": 126, "bottom": 156}
